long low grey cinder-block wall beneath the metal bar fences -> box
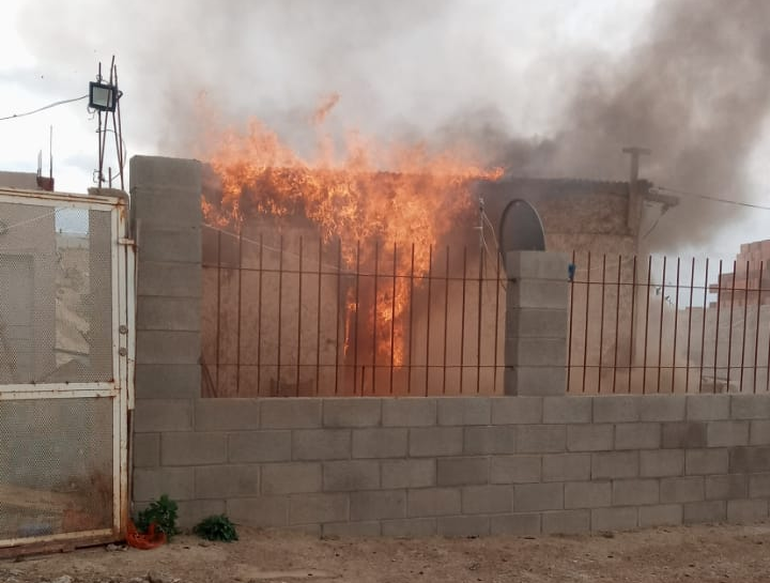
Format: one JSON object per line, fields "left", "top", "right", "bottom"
{"left": 134, "top": 395, "right": 770, "bottom": 536}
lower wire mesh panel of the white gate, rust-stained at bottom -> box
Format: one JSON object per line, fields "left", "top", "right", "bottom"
{"left": 0, "top": 398, "right": 115, "bottom": 540}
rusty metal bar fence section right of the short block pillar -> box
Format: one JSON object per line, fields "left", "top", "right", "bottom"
{"left": 567, "top": 253, "right": 770, "bottom": 393}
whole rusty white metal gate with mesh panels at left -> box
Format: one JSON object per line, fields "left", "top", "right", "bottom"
{"left": 0, "top": 189, "right": 135, "bottom": 556}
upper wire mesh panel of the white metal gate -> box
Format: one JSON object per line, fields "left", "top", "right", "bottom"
{"left": 0, "top": 202, "right": 113, "bottom": 384}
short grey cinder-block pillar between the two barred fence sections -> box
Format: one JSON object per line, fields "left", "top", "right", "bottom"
{"left": 504, "top": 251, "right": 569, "bottom": 395}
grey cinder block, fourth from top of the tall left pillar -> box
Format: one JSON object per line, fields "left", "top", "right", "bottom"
{"left": 136, "top": 256, "right": 203, "bottom": 302}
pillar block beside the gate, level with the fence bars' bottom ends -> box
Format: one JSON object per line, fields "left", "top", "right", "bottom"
{"left": 134, "top": 363, "right": 201, "bottom": 402}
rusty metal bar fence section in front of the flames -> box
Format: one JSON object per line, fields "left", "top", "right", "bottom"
{"left": 201, "top": 227, "right": 505, "bottom": 397}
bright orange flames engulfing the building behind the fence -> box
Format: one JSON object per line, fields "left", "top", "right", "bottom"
{"left": 195, "top": 94, "right": 502, "bottom": 366}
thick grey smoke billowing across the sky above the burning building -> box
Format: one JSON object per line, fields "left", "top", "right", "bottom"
{"left": 15, "top": 0, "right": 770, "bottom": 251}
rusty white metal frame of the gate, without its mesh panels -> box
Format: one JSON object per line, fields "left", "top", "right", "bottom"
{"left": 0, "top": 188, "right": 136, "bottom": 557}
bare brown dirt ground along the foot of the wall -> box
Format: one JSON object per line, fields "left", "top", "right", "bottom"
{"left": 0, "top": 524, "right": 770, "bottom": 583}
